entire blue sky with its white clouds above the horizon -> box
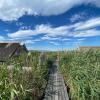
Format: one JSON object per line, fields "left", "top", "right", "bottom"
{"left": 0, "top": 0, "right": 100, "bottom": 50}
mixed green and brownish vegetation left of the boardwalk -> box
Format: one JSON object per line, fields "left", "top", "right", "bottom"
{"left": 0, "top": 52, "right": 49, "bottom": 100}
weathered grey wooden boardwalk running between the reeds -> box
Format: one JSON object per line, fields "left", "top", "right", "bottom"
{"left": 44, "top": 61, "right": 69, "bottom": 100}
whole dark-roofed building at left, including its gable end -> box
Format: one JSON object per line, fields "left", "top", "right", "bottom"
{"left": 0, "top": 43, "right": 27, "bottom": 62}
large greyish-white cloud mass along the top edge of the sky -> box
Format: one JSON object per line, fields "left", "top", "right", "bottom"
{"left": 0, "top": 0, "right": 100, "bottom": 21}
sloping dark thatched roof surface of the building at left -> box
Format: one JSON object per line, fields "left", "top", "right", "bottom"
{"left": 0, "top": 43, "right": 27, "bottom": 62}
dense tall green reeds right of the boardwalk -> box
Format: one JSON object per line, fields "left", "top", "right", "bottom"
{"left": 60, "top": 49, "right": 100, "bottom": 100}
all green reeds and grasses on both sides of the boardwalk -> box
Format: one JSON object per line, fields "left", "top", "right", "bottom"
{"left": 0, "top": 49, "right": 100, "bottom": 100}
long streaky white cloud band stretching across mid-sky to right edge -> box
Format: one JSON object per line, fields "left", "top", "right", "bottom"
{"left": 8, "top": 17, "right": 100, "bottom": 41}
